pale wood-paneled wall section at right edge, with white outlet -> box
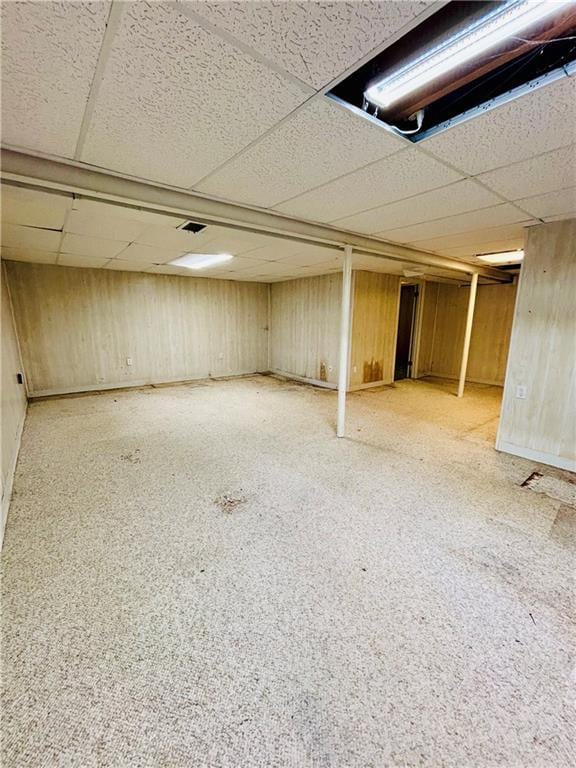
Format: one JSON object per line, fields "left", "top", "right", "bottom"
{"left": 496, "top": 219, "right": 576, "bottom": 471}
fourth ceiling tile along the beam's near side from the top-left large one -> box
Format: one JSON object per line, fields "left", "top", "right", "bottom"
{"left": 334, "top": 179, "right": 500, "bottom": 234}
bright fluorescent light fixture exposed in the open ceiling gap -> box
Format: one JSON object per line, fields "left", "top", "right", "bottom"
{"left": 364, "top": 0, "right": 574, "bottom": 108}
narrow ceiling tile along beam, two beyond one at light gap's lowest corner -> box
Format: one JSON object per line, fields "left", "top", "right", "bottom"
{"left": 378, "top": 203, "right": 528, "bottom": 243}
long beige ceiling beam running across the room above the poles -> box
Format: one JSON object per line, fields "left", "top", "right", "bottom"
{"left": 1, "top": 148, "right": 511, "bottom": 282}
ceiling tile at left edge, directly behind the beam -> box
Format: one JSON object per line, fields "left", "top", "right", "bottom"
{"left": 2, "top": 184, "right": 72, "bottom": 229}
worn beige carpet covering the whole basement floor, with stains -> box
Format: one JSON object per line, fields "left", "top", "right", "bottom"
{"left": 2, "top": 377, "right": 576, "bottom": 768}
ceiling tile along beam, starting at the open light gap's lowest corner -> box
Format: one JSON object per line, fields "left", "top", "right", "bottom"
{"left": 276, "top": 148, "right": 462, "bottom": 222}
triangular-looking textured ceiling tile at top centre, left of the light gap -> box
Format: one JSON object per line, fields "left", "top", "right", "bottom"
{"left": 184, "top": 0, "right": 427, "bottom": 89}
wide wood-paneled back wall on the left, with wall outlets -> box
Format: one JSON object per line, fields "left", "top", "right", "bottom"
{"left": 7, "top": 262, "right": 268, "bottom": 395}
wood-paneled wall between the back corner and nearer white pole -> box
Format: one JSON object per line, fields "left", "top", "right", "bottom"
{"left": 270, "top": 274, "right": 342, "bottom": 385}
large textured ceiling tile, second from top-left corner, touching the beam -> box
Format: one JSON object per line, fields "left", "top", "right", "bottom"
{"left": 82, "top": 1, "right": 308, "bottom": 187}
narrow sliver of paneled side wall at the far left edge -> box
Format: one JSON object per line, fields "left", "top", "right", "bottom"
{"left": 0, "top": 265, "right": 28, "bottom": 546}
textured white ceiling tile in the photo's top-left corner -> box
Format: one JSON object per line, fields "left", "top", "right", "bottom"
{"left": 2, "top": 1, "right": 109, "bottom": 157}
